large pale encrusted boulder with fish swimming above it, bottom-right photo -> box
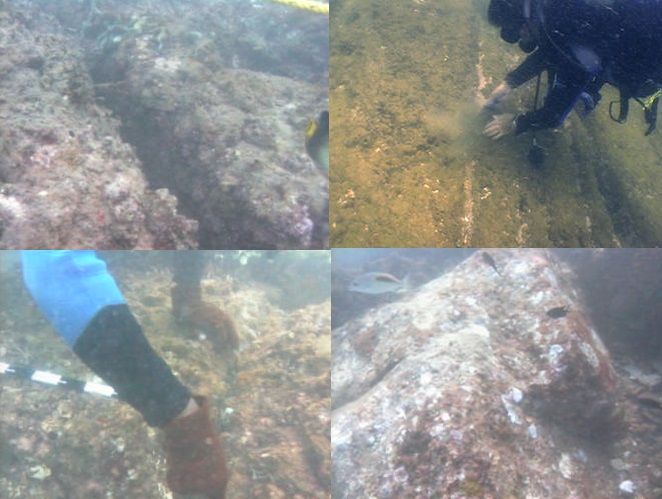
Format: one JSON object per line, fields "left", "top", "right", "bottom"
{"left": 332, "top": 250, "right": 632, "bottom": 498}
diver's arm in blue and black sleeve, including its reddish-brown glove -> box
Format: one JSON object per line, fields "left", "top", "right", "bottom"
{"left": 21, "top": 251, "right": 228, "bottom": 499}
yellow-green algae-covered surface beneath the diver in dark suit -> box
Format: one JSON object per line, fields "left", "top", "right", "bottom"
{"left": 330, "top": 0, "right": 662, "bottom": 247}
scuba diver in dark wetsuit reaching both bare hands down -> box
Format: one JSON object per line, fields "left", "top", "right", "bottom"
{"left": 483, "top": 0, "right": 662, "bottom": 140}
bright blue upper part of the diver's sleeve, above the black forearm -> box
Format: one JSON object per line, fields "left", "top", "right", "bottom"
{"left": 21, "top": 250, "right": 125, "bottom": 347}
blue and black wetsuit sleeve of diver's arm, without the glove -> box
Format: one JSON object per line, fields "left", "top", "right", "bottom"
{"left": 21, "top": 250, "right": 191, "bottom": 426}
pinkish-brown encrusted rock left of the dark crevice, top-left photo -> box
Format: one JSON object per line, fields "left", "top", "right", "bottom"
{"left": 0, "top": 3, "right": 197, "bottom": 249}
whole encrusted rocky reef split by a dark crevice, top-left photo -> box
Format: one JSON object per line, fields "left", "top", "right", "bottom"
{"left": 0, "top": 0, "right": 328, "bottom": 249}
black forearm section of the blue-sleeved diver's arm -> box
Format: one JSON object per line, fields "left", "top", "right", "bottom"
{"left": 74, "top": 305, "right": 191, "bottom": 426}
